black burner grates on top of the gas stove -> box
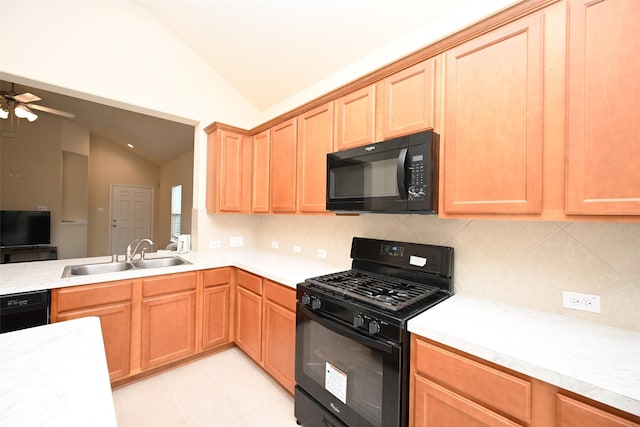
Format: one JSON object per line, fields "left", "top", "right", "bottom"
{"left": 307, "top": 270, "right": 439, "bottom": 311}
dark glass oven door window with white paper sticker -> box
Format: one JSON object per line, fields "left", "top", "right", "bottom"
{"left": 299, "top": 321, "right": 384, "bottom": 427}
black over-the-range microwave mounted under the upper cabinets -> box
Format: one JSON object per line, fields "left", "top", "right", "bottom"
{"left": 327, "top": 130, "right": 438, "bottom": 214}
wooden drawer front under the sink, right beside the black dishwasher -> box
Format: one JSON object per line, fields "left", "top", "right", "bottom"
{"left": 56, "top": 281, "right": 133, "bottom": 313}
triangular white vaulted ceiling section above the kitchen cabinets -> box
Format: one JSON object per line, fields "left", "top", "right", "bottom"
{"left": 133, "top": 0, "right": 504, "bottom": 111}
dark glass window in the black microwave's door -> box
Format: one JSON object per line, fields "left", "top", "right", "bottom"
{"left": 332, "top": 159, "right": 400, "bottom": 199}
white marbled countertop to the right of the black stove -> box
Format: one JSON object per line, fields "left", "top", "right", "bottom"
{"left": 409, "top": 295, "right": 640, "bottom": 416}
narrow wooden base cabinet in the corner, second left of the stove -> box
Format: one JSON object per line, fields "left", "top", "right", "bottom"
{"left": 235, "top": 270, "right": 262, "bottom": 364}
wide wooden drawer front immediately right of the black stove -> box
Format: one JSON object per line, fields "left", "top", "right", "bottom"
{"left": 415, "top": 339, "right": 531, "bottom": 423}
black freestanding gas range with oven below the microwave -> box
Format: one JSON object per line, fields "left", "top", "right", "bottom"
{"left": 295, "top": 237, "right": 453, "bottom": 427}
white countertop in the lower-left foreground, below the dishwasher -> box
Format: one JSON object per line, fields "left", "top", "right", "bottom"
{"left": 0, "top": 317, "right": 117, "bottom": 427}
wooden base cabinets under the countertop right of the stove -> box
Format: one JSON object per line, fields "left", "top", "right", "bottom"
{"left": 410, "top": 335, "right": 640, "bottom": 427}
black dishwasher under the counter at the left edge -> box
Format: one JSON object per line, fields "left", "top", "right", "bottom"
{"left": 0, "top": 290, "right": 51, "bottom": 333}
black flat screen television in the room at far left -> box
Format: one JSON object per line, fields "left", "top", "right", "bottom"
{"left": 0, "top": 211, "right": 51, "bottom": 248}
